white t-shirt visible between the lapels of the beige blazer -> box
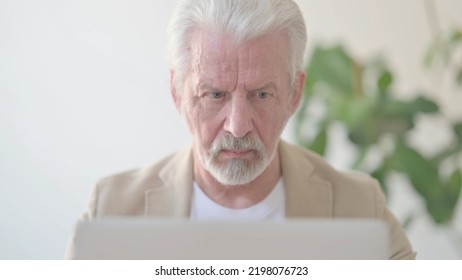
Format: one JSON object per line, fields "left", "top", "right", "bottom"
{"left": 191, "top": 177, "right": 285, "bottom": 221}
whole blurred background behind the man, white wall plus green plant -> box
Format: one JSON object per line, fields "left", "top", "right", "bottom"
{"left": 0, "top": 0, "right": 462, "bottom": 259}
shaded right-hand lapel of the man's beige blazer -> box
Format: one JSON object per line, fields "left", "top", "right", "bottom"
{"left": 279, "top": 140, "right": 333, "bottom": 218}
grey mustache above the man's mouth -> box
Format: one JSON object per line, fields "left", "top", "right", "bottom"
{"left": 210, "top": 134, "right": 264, "bottom": 156}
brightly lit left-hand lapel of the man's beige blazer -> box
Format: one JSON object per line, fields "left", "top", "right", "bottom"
{"left": 145, "top": 146, "right": 193, "bottom": 218}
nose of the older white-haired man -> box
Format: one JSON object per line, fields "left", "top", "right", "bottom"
{"left": 224, "top": 94, "right": 253, "bottom": 138}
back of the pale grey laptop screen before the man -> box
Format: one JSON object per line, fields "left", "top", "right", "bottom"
{"left": 70, "top": 218, "right": 389, "bottom": 260}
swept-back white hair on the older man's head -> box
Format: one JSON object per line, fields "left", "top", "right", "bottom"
{"left": 168, "top": 0, "right": 307, "bottom": 94}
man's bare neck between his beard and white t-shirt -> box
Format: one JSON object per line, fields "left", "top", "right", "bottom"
{"left": 194, "top": 151, "right": 282, "bottom": 209}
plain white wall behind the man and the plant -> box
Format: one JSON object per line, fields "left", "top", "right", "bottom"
{"left": 0, "top": 0, "right": 462, "bottom": 259}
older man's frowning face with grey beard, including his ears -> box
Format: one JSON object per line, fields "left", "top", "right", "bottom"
{"left": 174, "top": 31, "right": 304, "bottom": 185}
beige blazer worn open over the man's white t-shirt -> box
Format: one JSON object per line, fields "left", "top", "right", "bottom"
{"left": 68, "top": 140, "right": 415, "bottom": 259}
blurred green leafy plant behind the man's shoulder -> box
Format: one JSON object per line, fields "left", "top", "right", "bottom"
{"left": 295, "top": 46, "right": 462, "bottom": 224}
